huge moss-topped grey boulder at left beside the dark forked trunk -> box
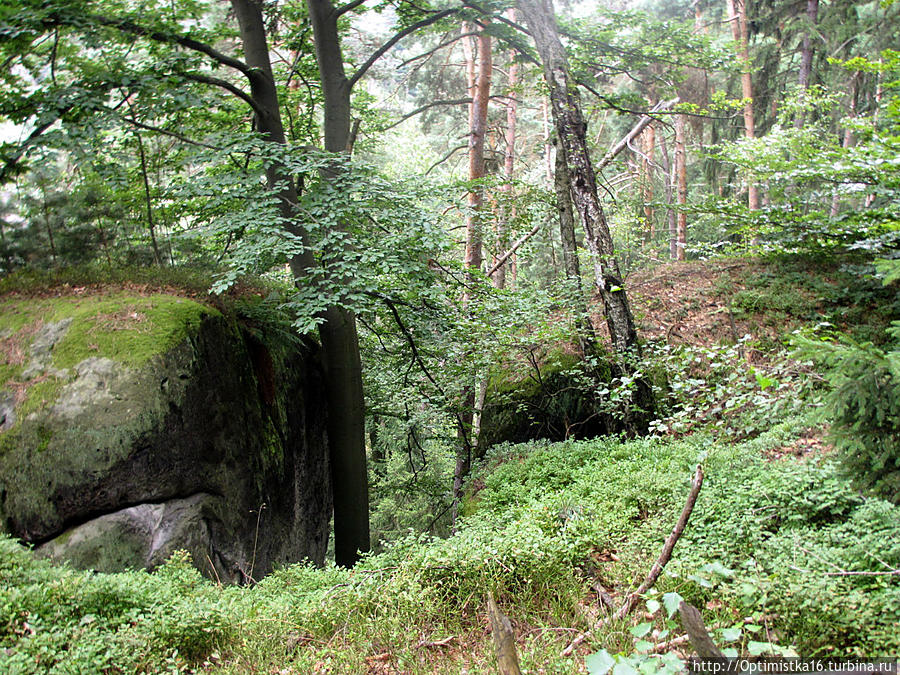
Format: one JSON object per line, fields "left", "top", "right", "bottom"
{"left": 0, "top": 292, "right": 332, "bottom": 582}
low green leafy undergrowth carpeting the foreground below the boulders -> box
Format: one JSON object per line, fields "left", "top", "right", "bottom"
{"left": 0, "top": 422, "right": 900, "bottom": 673}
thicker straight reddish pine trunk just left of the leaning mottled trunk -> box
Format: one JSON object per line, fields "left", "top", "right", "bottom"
{"left": 452, "top": 25, "right": 493, "bottom": 522}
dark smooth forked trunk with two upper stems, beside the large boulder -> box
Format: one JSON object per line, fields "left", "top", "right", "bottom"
{"left": 231, "top": 0, "right": 369, "bottom": 566}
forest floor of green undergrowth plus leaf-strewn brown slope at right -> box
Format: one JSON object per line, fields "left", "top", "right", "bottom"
{"left": 0, "top": 260, "right": 900, "bottom": 675}
